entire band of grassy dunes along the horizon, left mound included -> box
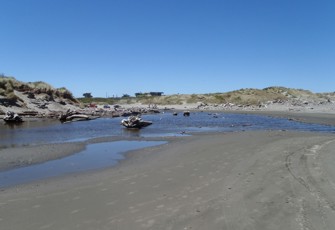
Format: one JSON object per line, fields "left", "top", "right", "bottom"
{"left": 0, "top": 75, "right": 335, "bottom": 106}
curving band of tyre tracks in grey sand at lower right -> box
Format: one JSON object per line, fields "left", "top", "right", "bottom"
{"left": 285, "top": 137, "right": 335, "bottom": 230}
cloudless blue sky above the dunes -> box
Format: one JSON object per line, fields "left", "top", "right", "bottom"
{"left": 0, "top": 0, "right": 335, "bottom": 97}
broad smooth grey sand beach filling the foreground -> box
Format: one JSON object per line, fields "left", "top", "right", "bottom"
{"left": 0, "top": 113, "right": 335, "bottom": 230}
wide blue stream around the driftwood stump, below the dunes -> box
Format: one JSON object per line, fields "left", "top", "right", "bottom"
{"left": 0, "top": 112, "right": 335, "bottom": 148}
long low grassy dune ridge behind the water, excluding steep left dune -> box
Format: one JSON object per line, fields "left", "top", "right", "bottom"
{"left": 78, "top": 87, "right": 335, "bottom": 106}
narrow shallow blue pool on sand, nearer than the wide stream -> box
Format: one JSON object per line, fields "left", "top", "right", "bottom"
{"left": 0, "top": 141, "right": 166, "bottom": 188}
